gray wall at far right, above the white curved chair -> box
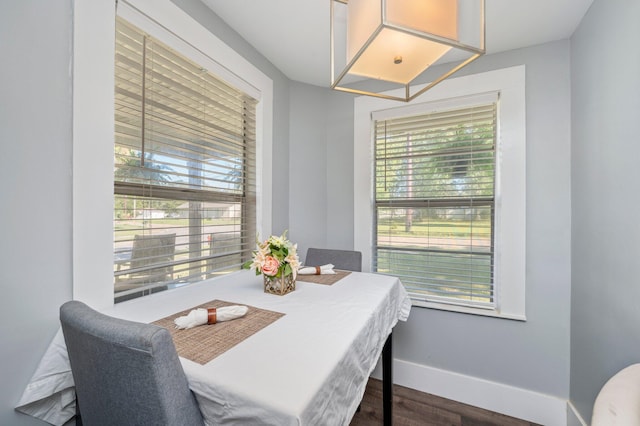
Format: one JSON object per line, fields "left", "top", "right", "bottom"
{"left": 571, "top": 0, "right": 640, "bottom": 421}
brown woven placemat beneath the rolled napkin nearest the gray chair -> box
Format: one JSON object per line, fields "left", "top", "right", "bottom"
{"left": 153, "top": 300, "right": 285, "bottom": 365}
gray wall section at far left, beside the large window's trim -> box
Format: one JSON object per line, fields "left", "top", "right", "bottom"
{"left": 0, "top": 0, "right": 72, "bottom": 425}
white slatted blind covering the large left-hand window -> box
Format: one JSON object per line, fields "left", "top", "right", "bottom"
{"left": 114, "top": 18, "right": 256, "bottom": 301}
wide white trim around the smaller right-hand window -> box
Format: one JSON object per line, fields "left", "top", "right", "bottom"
{"left": 354, "top": 65, "right": 526, "bottom": 321}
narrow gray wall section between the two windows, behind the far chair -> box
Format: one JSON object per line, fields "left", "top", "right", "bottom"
{"left": 289, "top": 82, "right": 353, "bottom": 261}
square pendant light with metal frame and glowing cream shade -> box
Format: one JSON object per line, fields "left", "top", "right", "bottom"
{"left": 330, "top": 0, "right": 485, "bottom": 102}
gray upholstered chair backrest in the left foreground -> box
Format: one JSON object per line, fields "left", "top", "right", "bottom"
{"left": 60, "top": 301, "right": 203, "bottom": 425}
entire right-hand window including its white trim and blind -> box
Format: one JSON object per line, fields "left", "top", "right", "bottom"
{"left": 354, "top": 66, "right": 526, "bottom": 320}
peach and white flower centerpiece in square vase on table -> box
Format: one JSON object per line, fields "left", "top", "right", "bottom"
{"left": 242, "top": 231, "right": 300, "bottom": 296}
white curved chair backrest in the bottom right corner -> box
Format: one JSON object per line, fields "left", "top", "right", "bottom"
{"left": 591, "top": 364, "right": 640, "bottom": 426}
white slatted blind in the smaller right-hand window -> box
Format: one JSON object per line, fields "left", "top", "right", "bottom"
{"left": 373, "top": 99, "right": 497, "bottom": 308}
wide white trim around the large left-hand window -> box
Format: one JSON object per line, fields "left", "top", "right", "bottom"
{"left": 70, "top": 0, "right": 273, "bottom": 309}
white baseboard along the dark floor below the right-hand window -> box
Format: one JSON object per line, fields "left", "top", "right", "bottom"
{"left": 372, "top": 359, "right": 568, "bottom": 426}
